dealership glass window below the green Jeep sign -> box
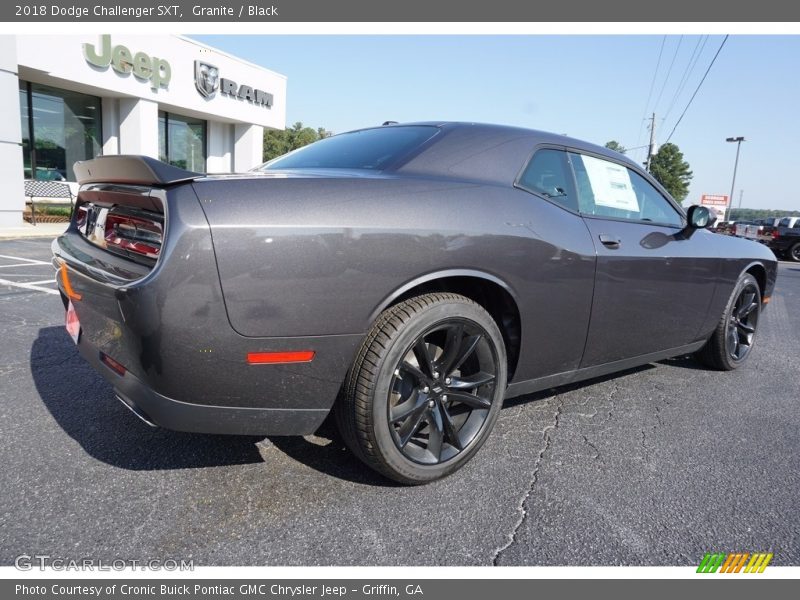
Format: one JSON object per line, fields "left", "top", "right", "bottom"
{"left": 19, "top": 81, "right": 102, "bottom": 181}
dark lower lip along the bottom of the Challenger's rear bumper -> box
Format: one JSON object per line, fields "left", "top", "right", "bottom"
{"left": 78, "top": 314, "right": 329, "bottom": 435}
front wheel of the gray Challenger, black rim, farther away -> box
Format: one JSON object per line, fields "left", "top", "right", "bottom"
{"left": 697, "top": 273, "right": 761, "bottom": 371}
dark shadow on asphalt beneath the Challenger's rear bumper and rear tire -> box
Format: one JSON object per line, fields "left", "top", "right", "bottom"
{"left": 30, "top": 327, "right": 396, "bottom": 486}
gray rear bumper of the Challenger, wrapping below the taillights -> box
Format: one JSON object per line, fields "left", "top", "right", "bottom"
{"left": 52, "top": 186, "right": 363, "bottom": 435}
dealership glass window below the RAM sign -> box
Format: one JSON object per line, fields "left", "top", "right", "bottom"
{"left": 158, "top": 111, "right": 206, "bottom": 173}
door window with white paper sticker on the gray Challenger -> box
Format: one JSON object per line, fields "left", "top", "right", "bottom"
{"left": 569, "top": 154, "right": 682, "bottom": 227}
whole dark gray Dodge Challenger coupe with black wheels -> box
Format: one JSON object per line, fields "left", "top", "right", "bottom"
{"left": 53, "top": 123, "right": 777, "bottom": 484}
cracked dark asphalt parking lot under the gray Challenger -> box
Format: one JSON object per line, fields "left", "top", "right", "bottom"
{"left": 0, "top": 239, "right": 800, "bottom": 565}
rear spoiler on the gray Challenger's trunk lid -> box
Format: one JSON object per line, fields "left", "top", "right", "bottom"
{"left": 73, "top": 154, "right": 205, "bottom": 186}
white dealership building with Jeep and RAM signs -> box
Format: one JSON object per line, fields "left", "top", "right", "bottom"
{"left": 0, "top": 34, "right": 286, "bottom": 227}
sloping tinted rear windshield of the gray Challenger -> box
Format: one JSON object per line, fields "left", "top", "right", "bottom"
{"left": 259, "top": 125, "right": 438, "bottom": 170}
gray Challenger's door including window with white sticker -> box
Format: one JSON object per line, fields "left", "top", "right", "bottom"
{"left": 569, "top": 152, "right": 719, "bottom": 367}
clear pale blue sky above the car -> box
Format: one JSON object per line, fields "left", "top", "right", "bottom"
{"left": 191, "top": 35, "right": 800, "bottom": 210}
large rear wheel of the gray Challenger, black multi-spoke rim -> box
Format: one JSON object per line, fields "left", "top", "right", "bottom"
{"left": 334, "top": 293, "right": 507, "bottom": 485}
